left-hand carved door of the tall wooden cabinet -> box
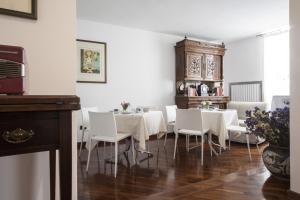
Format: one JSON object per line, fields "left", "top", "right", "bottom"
{"left": 185, "top": 52, "right": 203, "bottom": 80}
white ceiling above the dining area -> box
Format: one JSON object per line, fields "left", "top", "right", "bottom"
{"left": 77, "top": 0, "right": 289, "bottom": 42}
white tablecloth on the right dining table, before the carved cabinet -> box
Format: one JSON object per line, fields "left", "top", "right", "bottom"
{"left": 201, "top": 109, "right": 238, "bottom": 148}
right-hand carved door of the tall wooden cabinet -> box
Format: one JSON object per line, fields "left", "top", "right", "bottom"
{"left": 202, "top": 54, "right": 222, "bottom": 80}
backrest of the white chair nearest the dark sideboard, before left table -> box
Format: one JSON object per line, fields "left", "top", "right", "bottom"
{"left": 89, "top": 111, "right": 117, "bottom": 138}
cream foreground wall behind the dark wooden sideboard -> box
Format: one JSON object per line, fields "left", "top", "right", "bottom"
{"left": 0, "top": 0, "right": 77, "bottom": 200}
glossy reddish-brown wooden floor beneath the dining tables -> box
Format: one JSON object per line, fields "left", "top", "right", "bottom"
{"left": 78, "top": 137, "right": 289, "bottom": 200}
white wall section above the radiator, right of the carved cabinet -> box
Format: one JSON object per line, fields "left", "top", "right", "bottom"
{"left": 223, "top": 36, "right": 264, "bottom": 95}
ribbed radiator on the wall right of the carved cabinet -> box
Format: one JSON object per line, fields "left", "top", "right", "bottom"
{"left": 229, "top": 81, "right": 263, "bottom": 102}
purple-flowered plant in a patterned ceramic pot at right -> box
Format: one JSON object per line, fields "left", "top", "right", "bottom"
{"left": 245, "top": 106, "right": 290, "bottom": 178}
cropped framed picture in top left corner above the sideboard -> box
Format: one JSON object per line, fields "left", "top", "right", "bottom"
{"left": 0, "top": 0, "right": 37, "bottom": 19}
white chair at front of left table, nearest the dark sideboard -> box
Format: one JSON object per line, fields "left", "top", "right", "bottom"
{"left": 86, "top": 111, "right": 135, "bottom": 178}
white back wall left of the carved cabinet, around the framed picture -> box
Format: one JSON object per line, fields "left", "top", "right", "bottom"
{"left": 77, "top": 20, "right": 183, "bottom": 136}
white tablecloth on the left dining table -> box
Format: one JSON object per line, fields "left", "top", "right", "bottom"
{"left": 86, "top": 111, "right": 167, "bottom": 150}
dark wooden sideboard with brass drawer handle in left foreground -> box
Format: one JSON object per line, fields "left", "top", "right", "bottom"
{"left": 0, "top": 95, "right": 80, "bottom": 200}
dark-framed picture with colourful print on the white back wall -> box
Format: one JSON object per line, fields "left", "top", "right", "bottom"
{"left": 77, "top": 40, "right": 106, "bottom": 83}
